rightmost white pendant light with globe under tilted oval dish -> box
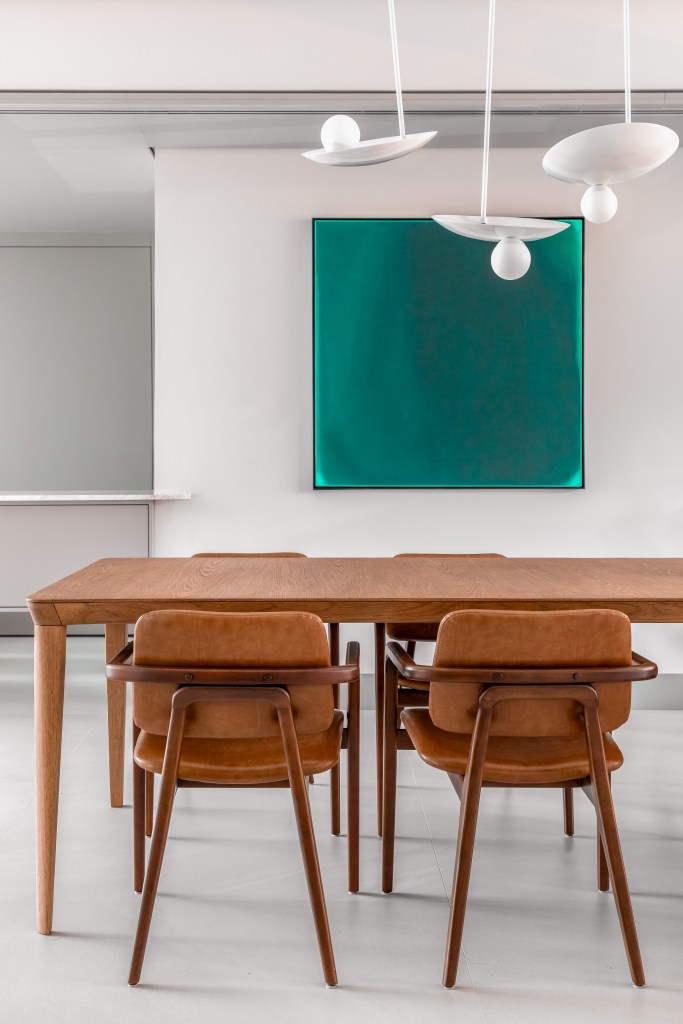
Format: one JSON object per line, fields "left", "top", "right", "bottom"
{"left": 543, "top": 0, "right": 678, "bottom": 224}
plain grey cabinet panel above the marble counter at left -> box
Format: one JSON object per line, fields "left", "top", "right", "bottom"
{"left": 0, "top": 243, "right": 153, "bottom": 492}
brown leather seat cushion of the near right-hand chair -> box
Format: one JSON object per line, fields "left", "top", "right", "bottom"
{"left": 401, "top": 708, "right": 624, "bottom": 785}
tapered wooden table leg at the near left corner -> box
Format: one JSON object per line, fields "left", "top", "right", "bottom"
{"left": 35, "top": 626, "right": 67, "bottom": 935}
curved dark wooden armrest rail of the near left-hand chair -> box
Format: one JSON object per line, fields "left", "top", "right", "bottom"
{"left": 106, "top": 642, "right": 359, "bottom": 686}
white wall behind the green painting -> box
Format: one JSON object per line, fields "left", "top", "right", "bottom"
{"left": 155, "top": 150, "right": 683, "bottom": 672}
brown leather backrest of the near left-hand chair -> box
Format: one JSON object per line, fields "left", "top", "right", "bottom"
{"left": 133, "top": 610, "right": 334, "bottom": 739}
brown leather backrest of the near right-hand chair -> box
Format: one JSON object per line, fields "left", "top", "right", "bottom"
{"left": 429, "top": 609, "right": 631, "bottom": 736}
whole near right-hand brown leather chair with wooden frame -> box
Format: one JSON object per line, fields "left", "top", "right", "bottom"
{"left": 382, "top": 609, "right": 657, "bottom": 988}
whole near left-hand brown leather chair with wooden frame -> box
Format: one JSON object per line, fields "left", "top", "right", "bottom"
{"left": 106, "top": 611, "right": 359, "bottom": 985}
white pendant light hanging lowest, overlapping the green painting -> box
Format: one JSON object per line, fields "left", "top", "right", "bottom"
{"left": 432, "top": 0, "right": 569, "bottom": 281}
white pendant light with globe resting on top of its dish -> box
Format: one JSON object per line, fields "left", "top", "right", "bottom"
{"left": 302, "top": 0, "right": 436, "bottom": 167}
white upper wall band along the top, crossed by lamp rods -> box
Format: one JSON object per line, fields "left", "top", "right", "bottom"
{"left": 0, "top": 0, "right": 683, "bottom": 90}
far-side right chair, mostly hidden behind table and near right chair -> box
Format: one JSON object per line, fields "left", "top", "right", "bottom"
{"left": 375, "top": 553, "right": 505, "bottom": 836}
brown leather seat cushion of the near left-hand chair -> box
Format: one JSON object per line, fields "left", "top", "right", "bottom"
{"left": 134, "top": 711, "right": 344, "bottom": 785}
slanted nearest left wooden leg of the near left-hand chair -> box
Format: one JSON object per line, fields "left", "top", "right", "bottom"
{"left": 128, "top": 708, "right": 185, "bottom": 985}
